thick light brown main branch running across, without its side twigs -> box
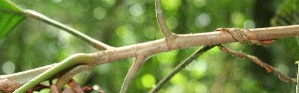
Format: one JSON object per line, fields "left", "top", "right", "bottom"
{"left": 0, "top": 25, "right": 299, "bottom": 92}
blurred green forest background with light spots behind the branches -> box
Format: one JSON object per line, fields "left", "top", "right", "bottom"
{"left": 0, "top": 0, "right": 299, "bottom": 93}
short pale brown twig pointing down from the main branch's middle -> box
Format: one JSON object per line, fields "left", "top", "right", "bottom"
{"left": 119, "top": 54, "right": 147, "bottom": 93}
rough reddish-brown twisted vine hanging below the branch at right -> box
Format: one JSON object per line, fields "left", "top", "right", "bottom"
{"left": 218, "top": 45, "right": 296, "bottom": 83}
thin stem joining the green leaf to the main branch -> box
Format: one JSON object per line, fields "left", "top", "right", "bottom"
{"left": 24, "top": 10, "right": 113, "bottom": 50}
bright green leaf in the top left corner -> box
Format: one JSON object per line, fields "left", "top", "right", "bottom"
{"left": 0, "top": 0, "right": 25, "bottom": 40}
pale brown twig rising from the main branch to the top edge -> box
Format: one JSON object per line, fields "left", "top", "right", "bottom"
{"left": 155, "top": 0, "right": 175, "bottom": 41}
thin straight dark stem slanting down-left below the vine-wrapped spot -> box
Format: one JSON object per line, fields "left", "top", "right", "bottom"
{"left": 149, "top": 46, "right": 214, "bottom": 93}
